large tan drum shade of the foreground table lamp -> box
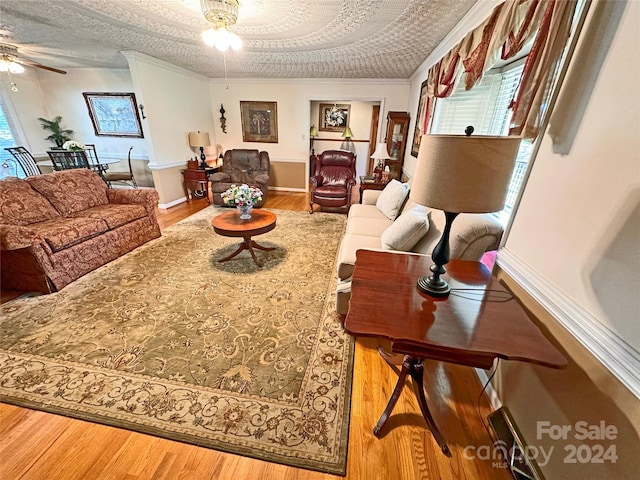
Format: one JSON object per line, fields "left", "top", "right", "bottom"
{"left": 409, "top": 135, "right": 520, "bottom": 213}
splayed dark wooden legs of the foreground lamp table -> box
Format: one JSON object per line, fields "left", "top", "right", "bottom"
{"left": 373, "top": 356, "right": 451, "bottom": 457}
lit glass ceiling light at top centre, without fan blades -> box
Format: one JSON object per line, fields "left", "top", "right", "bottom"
{"left": 200, "top": 0, "right": 242, "bottom": 52}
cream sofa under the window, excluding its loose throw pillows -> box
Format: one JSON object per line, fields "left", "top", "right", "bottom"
{"left": 336, "top": 190, "right": 503, "bottom": 315}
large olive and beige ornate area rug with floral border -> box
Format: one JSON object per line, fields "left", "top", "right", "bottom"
{"left": 0, "top": 207, "right": 353, "bottom": 475}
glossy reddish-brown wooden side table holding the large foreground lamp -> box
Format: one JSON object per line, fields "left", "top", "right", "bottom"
{"left": 344, "top": 250, "right": 567, "bottom": 456}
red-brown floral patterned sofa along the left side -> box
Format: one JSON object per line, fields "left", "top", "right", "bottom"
{"left": 0, "top": 169, "right": 160, "bottom": 293}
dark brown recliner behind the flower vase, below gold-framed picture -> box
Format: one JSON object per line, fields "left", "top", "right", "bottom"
{"left": 209, "top": 149, "right": 271, "bottom": 207}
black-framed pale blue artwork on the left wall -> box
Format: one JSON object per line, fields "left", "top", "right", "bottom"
{"left": 82, "top": 92, "right": 144, "bottom": 138}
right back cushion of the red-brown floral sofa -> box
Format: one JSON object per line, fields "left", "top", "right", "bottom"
{"left": 26, "top": 168, "right": 109, "bottom": 216}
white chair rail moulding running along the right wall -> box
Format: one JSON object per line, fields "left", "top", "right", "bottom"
{"left": 497, "top": 248, "right": 640, "bottom": 398}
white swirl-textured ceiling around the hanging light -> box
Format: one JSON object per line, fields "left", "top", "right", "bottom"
{"left": 0, "top": 0, "right": 476, "bottom": 78}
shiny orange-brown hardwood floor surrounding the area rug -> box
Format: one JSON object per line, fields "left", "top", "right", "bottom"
{"left": 0, "top": 192, "right": 511, "bottom": 480}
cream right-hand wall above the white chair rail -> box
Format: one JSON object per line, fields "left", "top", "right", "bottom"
{"left": 505, "top": 2, "right": 640, "bottom": 352}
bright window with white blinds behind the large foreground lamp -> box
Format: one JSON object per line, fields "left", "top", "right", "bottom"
{"left": 431, "top": 60, "right": 533, "bottom": 225}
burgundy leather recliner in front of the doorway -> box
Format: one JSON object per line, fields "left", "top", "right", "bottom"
{"left": 309, "top": 150, "right": 356, "bottom": 213}
